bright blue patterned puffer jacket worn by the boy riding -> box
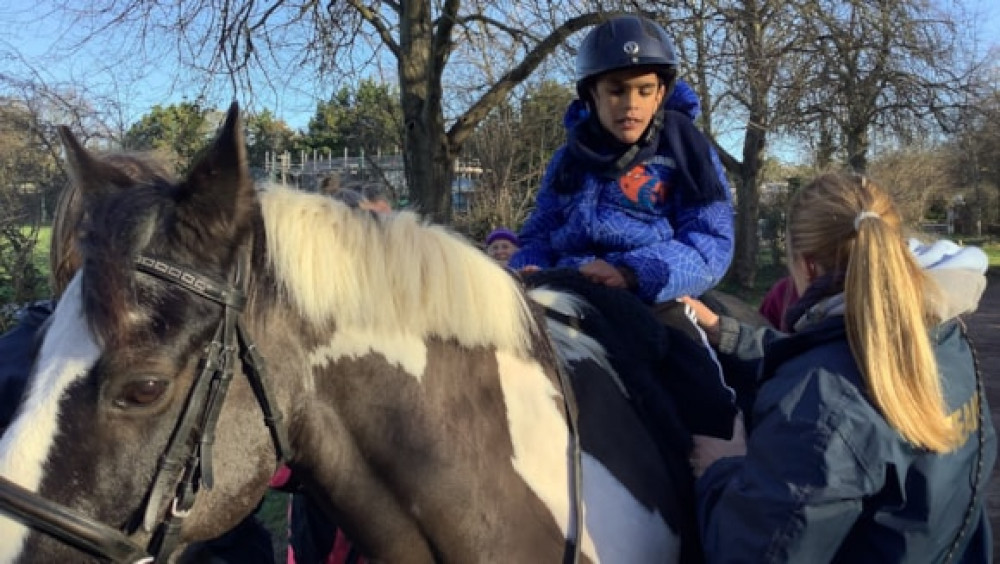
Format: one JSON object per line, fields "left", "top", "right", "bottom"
{"left": 509, "top": 81, "right": 733, "bottom": 303}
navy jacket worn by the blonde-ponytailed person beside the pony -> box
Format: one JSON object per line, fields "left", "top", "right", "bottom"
{"left": 696, "top": 315, "right": 996, "bottom": 564}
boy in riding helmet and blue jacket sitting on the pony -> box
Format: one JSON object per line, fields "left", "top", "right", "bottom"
{"left": 507, "top": 15, "right": 736, "bottom": 437}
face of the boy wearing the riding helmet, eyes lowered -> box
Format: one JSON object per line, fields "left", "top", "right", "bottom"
{"left": 591, "top": 69, "right": 666, "bottom": 145}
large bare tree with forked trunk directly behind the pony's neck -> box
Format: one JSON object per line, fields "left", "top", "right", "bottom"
{"left": 39, "top": 0, "right": 640, "bottom": 221}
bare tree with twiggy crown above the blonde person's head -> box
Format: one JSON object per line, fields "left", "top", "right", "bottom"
{"left": 795, "top": 0, "right": 976, "bottom": 172}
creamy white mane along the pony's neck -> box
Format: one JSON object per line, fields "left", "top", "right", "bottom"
{"left": 259, "top": 186, "right": 532, "bottom": 356}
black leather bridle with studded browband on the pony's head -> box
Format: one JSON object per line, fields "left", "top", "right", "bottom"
{"left": 0, "top": 255, "right": 292, "bottom": 564}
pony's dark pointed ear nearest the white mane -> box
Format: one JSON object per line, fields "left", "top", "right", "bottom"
{"left": 175, "top": 102, "right": 254, "bottom": 238}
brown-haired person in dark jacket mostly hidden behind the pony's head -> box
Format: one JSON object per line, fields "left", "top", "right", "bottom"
{"left": 0, "top": 150, "right": 274, "bottom": 564}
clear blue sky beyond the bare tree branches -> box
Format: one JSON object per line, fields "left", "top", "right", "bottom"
{"left": 0, "top": 0, "right": 1000, "bottom": 156}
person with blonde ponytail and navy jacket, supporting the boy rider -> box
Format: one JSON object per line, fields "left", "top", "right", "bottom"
{"left": 680, "top": 174, "right": 996, "bottom": 564}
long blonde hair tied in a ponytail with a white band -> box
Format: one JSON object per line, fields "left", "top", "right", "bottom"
{"left": 789, "top": 174, "right": 962, "bottom": 452}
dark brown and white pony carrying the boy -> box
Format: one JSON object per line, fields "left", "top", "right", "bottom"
{"left": 0, "top": 104, "right": 698, "bottom": 564}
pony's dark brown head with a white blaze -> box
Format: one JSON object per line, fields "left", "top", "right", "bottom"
{"left": 0, "top": 105, "right": 274, "bottom": 562}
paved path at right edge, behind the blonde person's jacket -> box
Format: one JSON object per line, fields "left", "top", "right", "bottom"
{"left": 966, "top": 274, "right": 1000, "bottom": 562}
